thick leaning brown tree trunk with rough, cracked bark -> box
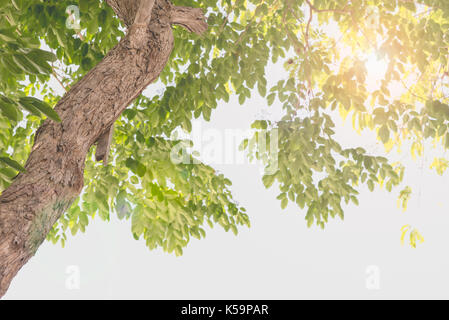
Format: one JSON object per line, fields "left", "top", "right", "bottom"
{"left": 0, "top": 0, "right": 207, "bottom": 297}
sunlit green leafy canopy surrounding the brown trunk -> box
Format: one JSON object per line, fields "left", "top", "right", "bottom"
{"left": 0, "top": 0, "right": 449, "bottom": 254}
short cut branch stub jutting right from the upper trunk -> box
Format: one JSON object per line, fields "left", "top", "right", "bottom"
{"left": 171, "top": 6, "right": 209, "bottom": 34}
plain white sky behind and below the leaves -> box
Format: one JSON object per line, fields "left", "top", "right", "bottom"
{"left": 5, "top": 14, "right": 449, "bottom": 299}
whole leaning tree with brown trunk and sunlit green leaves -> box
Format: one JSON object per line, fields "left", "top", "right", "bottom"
{"left": 0, "top": 0, "right": 449, "bottom": 296}
